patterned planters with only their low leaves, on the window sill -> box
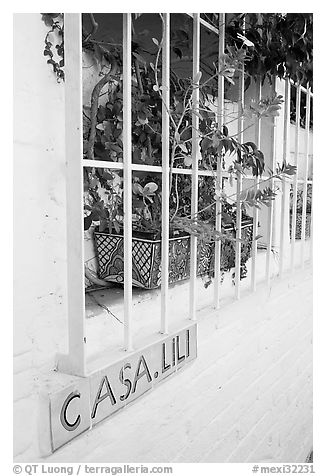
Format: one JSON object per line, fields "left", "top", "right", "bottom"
{"left": 85, "top": 171, "right": 252, "bottom": 289}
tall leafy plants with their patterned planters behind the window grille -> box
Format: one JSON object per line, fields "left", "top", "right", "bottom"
{"left": 84, "top": 13, "right": 293, "bottom": 289}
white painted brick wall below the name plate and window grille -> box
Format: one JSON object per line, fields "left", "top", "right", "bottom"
{"left": 34, "top": 269, "right": 312, "bottom": 463}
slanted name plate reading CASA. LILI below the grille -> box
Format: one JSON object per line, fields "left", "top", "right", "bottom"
{"left": 50, "top": 323, "right": 197, "bottom": 451}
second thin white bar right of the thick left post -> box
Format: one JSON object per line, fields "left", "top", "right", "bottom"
{"left": 161, "top": 13, "right": 170, "bottom": 334}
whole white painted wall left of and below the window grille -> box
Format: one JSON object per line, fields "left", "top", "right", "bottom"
{"left": 13, "top": 14, "right": 312, "bottom": 462}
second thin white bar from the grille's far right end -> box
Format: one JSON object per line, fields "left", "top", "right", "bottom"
{"left": 291, "top": 85, "right": 301, "bottom": 274}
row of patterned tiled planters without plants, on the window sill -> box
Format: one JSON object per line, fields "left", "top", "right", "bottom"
{"left": 94, "top": 221, "right": 252, "bottom": 289}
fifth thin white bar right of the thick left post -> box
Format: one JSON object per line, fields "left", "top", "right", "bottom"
{"left": 235, "top": 18, "right": 245, "bottom": 299}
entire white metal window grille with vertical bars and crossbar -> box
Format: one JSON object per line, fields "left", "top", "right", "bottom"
{"left": 59, "top": 13, "right": 312, "bottom": 376}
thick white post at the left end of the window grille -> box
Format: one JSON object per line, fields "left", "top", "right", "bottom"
{"left": 58, "top": 13, "right": 86, "bottom": 376}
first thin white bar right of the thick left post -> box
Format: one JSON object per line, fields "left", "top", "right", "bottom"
{"left": 123, "top": 13, "right": 132, "bottom": 351}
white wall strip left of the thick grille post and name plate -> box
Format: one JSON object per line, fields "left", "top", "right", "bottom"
{"left": 13, "top": 14, "right": 67, "bottom": 460}
